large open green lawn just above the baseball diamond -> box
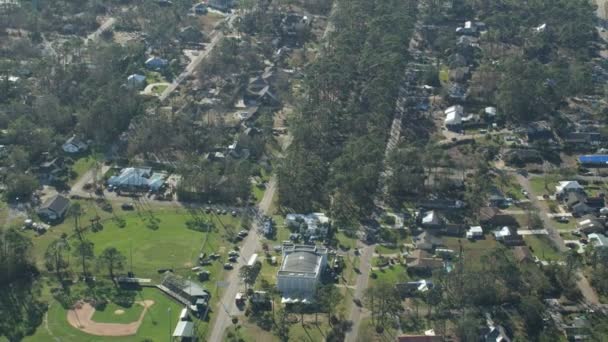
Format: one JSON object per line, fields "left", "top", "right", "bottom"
{"left": 29, "top": 201, "right": 239, "bottom": 281}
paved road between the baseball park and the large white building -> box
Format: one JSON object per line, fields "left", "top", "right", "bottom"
{"left": 209, "top": 177, "right": 276, "bottom": 342}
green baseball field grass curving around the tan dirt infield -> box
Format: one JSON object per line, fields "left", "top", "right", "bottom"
{"left": 24, "top": 288, "right": 182, "bottom": 342}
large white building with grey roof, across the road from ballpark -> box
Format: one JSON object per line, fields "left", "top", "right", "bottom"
{"left": 277, "top": 244, "right": 327, "bottom": 303}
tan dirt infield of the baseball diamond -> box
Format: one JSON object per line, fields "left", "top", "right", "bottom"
{"left": 68, "top": 300, "right": 154, "bottom": 336}
